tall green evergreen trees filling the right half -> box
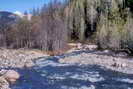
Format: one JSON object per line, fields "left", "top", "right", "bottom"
{"left": 67, "top": 0, "right": 133, "bottom": 54}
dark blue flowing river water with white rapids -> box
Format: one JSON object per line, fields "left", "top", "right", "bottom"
{"left": 11, "top": 57, "right": 133, "bottom": 89}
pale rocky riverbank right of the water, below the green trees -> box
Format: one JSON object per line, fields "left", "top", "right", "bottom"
{"left": 59, "top": 45, "right": 133, "bottom": 74}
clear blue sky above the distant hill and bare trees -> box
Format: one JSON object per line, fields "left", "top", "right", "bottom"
{"left": 0, "top": 0, "right": 50, "bottom": 12}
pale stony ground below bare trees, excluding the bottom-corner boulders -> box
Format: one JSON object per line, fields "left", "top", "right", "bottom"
{"left": 0, "top": 49, "right": 46, "bottom": 68}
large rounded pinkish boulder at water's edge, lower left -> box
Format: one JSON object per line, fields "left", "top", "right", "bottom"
{"left": 3, "top": 70, "right": 20, "bottom": 83}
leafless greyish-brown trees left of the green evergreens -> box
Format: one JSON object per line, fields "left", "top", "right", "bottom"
{"left": 0, "top": 0, "right": 67, "bottom": 51}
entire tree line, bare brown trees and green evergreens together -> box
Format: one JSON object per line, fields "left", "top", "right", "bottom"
{"left": 0, "top": 0, "right": 133, "bottom": 53}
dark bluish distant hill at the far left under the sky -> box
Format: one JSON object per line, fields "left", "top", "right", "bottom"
{"left": 0, "top": 11, "right": 20, "bottom": 27}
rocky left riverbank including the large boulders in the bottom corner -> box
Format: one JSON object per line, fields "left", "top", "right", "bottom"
{"left": 0, "top": 49, "right": 46, "bottom": 89}
